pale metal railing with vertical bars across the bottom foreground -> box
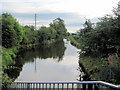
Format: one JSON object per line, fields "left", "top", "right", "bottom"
{"left": 8, "top": 81, "right": 120, "bottom": 90}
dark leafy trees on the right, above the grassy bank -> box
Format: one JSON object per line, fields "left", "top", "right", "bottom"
{"left": 79, "top": 13, "right": 120, "bottom": 57}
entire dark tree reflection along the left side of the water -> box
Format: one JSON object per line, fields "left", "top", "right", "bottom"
{"left": 4, "top": 40, "right": 66, "bottom": 80}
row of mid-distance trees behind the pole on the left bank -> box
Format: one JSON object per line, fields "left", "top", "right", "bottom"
{"left": 21, "top": 18, "right": 66, "bottom": 47}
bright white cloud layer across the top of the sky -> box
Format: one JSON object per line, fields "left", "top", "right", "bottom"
{"left": 3, "top": 0, "right": 119, "bottom": 18}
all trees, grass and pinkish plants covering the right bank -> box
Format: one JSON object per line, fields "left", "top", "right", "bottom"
{"left": 69, "top": 10, "right": 120, "bottom": 84}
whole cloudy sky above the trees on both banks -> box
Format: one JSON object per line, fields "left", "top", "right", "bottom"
{"left": 0, "top": 0, "right": 119, "bottom": 33}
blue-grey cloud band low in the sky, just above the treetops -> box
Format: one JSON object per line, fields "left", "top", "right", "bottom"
{"left": 4, "top": 12, "right": 85, "bottom": 32}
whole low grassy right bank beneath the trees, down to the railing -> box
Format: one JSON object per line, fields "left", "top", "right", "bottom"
{"left": 80, "top": 55, "right": 120, "bottom": 84}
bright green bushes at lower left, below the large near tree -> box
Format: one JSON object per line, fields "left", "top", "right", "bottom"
{"left": 0, "top": 47, "right": 17, "bottom": 88}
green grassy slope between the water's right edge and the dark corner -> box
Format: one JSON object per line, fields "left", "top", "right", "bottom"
{"left": 79, "top": 56, "right": 106, "bottom": 80}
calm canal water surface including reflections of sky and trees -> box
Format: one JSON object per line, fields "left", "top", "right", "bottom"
{"left": 11, "top": 39, "right": 82, "bottom": 82}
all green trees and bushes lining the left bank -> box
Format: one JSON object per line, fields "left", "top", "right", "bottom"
{"left": 0, "top": 13, "right": 67, "bottom": 86}
